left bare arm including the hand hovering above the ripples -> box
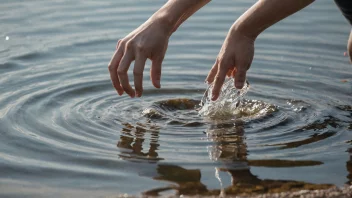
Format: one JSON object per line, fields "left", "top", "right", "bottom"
{"left": 108, "top": 0, "right": 210, "bottom": 97}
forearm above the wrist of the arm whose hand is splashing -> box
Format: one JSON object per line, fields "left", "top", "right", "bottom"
{"left": 233, "top": 0, "right": 314, "bottom": 39}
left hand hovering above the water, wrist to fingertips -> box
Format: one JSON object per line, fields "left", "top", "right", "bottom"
{"left": 108, "top": 19, "right": 172, "bottom": 98}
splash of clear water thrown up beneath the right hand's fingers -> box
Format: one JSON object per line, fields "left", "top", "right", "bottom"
{"left": 199, "top": 78, "right": 249, "bottom": 118}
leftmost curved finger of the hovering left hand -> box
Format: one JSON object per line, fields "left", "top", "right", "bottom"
{"left": 108, "top": 44, "right": 123, "bottom": 95}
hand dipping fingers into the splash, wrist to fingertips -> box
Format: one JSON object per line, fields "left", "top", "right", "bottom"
{"left": 206, "top": 27, "right": 254, "bottom": 101}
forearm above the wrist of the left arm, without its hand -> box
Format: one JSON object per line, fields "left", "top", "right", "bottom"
{"left": 151, "top": 0, "right": 210, "bottom": 34}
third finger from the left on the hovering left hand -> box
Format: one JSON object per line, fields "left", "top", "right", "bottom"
{"left": 133, "top": 55, "right": 147, "bottom": 97}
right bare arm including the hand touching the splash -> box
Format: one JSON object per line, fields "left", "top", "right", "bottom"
{"left": 207, "top": 0, "right": 314, "bottom": 100}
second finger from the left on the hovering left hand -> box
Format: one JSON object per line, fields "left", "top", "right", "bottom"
{"left": 117, "top": 52, "right": 135, "bottom": 98}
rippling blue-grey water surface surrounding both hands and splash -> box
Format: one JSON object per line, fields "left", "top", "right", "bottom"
{"left": 0, "top": 0, "right": 352, "bottom": 197}
